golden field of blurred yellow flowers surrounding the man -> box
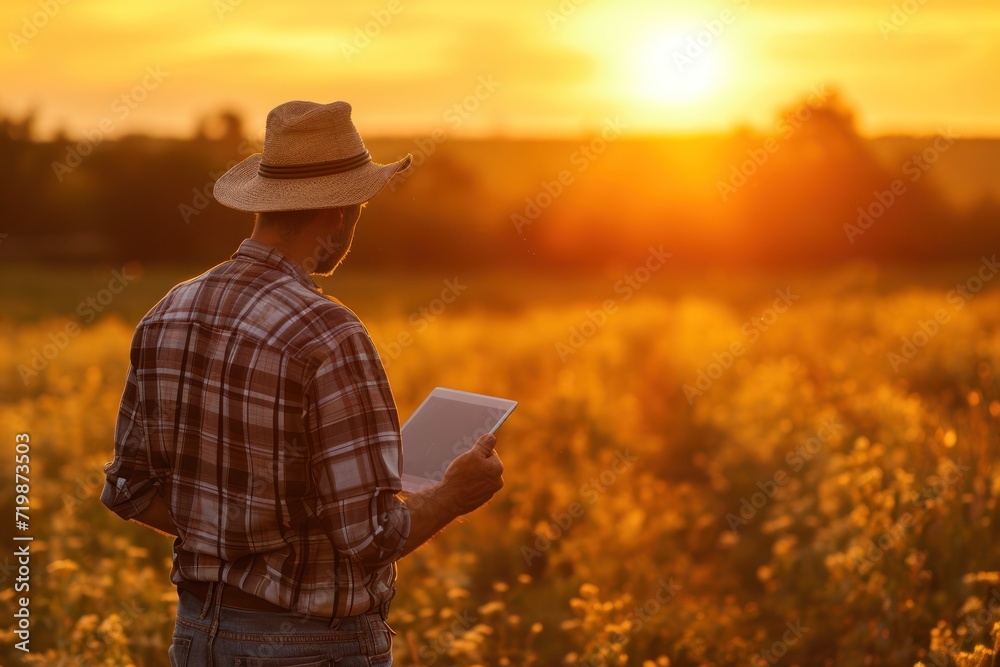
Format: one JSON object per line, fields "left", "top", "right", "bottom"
{"left": 0, "top": 262, "right": 1000, "bottom": 667}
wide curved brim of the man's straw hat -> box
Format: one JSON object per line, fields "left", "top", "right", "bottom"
{"left": 212, "top": 153, "right": 413, "bottom": 212}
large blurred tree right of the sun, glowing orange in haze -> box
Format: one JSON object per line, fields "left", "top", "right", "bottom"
{"left": 733, "top": 87, "right": 952, "bottom": 264}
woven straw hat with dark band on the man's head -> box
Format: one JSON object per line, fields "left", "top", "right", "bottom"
{"left": 213, "top": 101, "right": 413, "bottom": 212}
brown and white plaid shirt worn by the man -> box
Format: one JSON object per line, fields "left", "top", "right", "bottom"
{"left": 101, "top": 239, "right": 410, "bottom": 617}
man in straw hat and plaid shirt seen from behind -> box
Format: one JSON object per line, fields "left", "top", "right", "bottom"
{"left": 101, "top": 102, "right": 503, "bottom": 667}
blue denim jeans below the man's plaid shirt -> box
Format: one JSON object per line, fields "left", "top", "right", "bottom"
{"left": 168, "top": 587, "right": 395, "bottom": 667}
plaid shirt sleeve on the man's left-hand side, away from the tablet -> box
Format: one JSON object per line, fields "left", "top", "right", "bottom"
{"left": 101, "top": 365, "right": 161, "bottom": 520}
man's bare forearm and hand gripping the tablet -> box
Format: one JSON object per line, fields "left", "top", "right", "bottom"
{"left": 400, "top": 433, "right": 503, "bottom": 558}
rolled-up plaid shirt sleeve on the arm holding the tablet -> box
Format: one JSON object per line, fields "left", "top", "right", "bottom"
{"left": 306, "top": 328, "right": 410, "bottom": 568}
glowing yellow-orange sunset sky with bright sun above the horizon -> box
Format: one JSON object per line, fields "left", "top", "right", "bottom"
{"left": 0, "top": 0, "right": 1000, "bottom": 141}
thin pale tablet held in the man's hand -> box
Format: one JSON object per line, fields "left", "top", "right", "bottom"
{"left": 400, "top": 387, "right": 517, "bottom": 493}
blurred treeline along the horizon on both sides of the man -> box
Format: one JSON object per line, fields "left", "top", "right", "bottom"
{"left": 0, "top": 100, "right": 1000, "bottom": 271}
